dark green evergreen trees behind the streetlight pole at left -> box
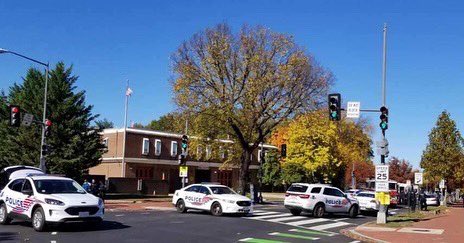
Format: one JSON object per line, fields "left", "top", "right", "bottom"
{"left": 0, "top": 63, "right": 104, "bottom": 178}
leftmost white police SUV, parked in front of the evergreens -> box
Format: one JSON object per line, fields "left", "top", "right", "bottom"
{"left": 0, "top": 173, "right": 104, "bottom": 231}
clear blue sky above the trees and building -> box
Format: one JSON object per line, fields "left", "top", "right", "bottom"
{"left": 0, "top": 0, "right": 464, "bottom": 167}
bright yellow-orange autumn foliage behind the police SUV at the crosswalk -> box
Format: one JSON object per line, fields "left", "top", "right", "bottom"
{"left": 271, "top": 111, "right": 374, "bottom": 186}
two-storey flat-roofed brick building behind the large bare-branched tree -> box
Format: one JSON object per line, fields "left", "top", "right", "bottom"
{"left": 89, "top": 128, "right": 277, "bottom": 192}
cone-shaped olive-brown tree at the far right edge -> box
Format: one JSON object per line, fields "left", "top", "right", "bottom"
{"left": 420, "top": 111, "right": 464, "bottom": 189}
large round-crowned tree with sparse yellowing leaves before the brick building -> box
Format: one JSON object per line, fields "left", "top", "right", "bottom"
{"left": 172, "top": 24, "right": 333, "bottom": 193}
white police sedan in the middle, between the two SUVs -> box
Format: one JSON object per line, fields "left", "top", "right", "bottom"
{"left": 172, "top": 183, "right": 253, "bottom": 216}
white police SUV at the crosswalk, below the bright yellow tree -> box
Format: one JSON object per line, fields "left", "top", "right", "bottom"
{"left": 284, "top": 183, "right": 359, "bottom": 218}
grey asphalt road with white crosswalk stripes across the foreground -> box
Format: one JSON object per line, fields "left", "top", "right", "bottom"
{"left": 0, "top": 204, "right": 404, "bottom": 243}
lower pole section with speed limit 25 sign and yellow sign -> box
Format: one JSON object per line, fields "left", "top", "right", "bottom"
{"left": 375, "top": 165, "right": 390, "bottom": 224}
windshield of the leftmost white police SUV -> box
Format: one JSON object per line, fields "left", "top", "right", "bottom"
{"left": 34, "top": 180, "right": 85, "bottom": 194}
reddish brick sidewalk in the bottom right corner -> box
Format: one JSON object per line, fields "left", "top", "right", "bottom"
{"left": 348, "top": 207, "right": 464, "bottom": 243}
